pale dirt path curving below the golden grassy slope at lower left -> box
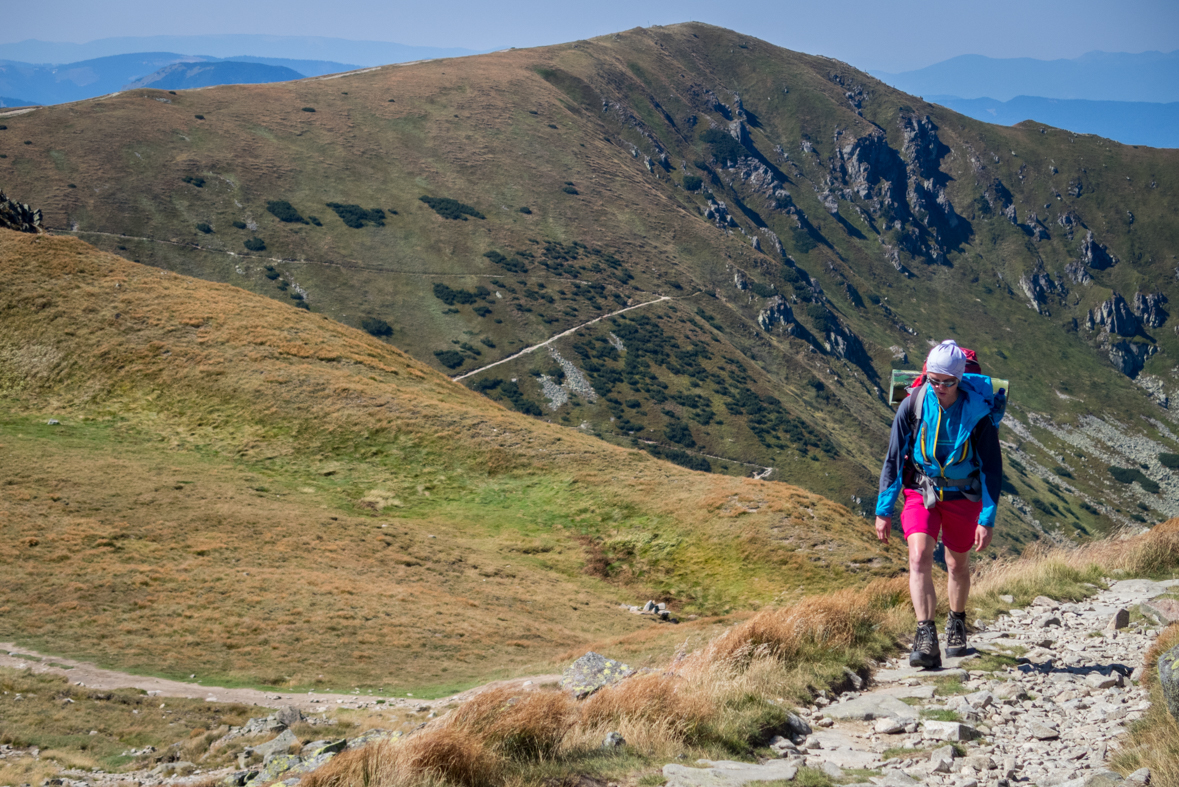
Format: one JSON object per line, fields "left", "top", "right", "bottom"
{"left": 0, "top": 642, "right": 559, "bottom": 713}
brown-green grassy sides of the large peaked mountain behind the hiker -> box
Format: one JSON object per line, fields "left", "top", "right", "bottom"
{"left": 0, "top": 25, "right": 1179, "bottom": 543}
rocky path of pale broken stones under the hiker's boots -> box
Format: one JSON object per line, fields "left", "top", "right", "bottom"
{"left": 664, "top": 580, "right": 1179, "bottom": 787}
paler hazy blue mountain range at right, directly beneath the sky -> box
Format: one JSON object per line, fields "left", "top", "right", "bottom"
{"left": 871, "top": 51, "right": 1179, "bottom": 104}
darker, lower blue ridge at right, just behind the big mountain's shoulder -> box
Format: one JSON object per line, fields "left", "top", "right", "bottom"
{"left": 926, "top": 95, "right": 1179, "bottom": 147}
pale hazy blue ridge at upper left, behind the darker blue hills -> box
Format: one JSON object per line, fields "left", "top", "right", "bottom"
{"left": 0, "top": 35, "right": 483, "bottom": 69}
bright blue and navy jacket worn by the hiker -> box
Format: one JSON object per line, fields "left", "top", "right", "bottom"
{"left": 876, "top": 375, "right": 1003, "bottom": 528}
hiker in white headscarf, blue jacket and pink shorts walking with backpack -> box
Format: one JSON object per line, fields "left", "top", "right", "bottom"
{"left": 876, "top": 339, "right": 1006, "bottom": 669}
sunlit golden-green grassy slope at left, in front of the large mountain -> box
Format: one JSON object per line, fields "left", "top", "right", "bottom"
{"left": 0, "top": 231, "right": 898, "bottom": 690}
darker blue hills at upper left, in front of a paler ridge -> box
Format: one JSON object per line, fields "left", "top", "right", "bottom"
{"left": 0, "top": 52, "right": 357, "bottom": 104}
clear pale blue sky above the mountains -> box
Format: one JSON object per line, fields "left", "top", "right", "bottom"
{"left": 9, "top": 0, "right": 1179, "bottom": 72}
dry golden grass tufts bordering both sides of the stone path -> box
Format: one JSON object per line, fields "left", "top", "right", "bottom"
{"left": 303, "top": 518, "right": 1179, "bottom": 787}
